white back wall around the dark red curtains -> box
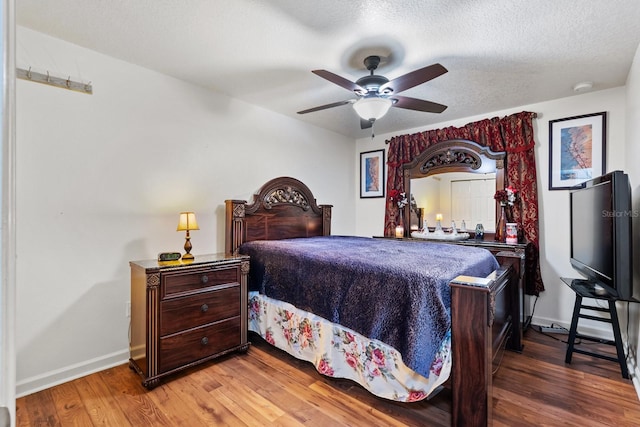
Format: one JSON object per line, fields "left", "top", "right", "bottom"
{"left": 356, "top": 87, "right": 631, "bottom": 337}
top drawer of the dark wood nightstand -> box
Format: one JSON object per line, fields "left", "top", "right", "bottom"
{"left": 161, "top": 266, "right": 240, "bottom": 299}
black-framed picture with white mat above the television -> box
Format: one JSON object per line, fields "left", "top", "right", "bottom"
{"left": 549, "top": 112, "right": 607, "bottom": 190}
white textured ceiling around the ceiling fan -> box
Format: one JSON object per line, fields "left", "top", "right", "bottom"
{"left": 16, "top": 0, "right": 640, "bottom": 138}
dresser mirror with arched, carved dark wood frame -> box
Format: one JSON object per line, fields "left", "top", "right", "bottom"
{"left": 403, "top": 139, "right": 505, "bottom": 232}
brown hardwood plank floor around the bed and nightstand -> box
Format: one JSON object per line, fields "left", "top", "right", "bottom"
{"left": 16, "top": 328, "right": 640, "bottom": 427}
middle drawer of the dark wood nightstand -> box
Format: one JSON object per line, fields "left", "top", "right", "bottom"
{"left": 160, "top": 283, "right": 240, "bottom": 336}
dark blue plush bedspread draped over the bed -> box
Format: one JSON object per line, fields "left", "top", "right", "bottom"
{"left": 240, "top": 236, "right": 498, "bottom": 377}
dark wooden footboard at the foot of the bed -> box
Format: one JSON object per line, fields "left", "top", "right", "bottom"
{"left": 451, "top": 266, "right": 521, "bottom": 427}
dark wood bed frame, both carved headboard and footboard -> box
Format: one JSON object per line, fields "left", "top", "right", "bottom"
{"left": 225, "top": 177, "right": 521, "bottom": 426}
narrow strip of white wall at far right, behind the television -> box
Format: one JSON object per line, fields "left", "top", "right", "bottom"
{"left": 618, "top": 40, "right": 640, "bottom": 397}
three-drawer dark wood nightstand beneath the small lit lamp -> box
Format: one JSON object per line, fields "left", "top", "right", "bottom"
{"left": 129, "top": 254, "right": 249, "bottom": 388}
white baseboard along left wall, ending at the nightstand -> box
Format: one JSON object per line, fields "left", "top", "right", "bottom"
{"left": 16, "top": 349, "right": 129, "bottom": 397}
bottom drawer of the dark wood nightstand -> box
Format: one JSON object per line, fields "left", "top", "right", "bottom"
{"left": 159, "top": 316, "right": 241, "bottom": 372}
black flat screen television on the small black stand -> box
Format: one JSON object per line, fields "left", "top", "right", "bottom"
{"left": 569, "top": 171, "right": 633, "bottom": 300}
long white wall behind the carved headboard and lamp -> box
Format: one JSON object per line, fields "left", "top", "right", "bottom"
{"left": 16, "top": 27, "right": 356, "bottom": 395}
